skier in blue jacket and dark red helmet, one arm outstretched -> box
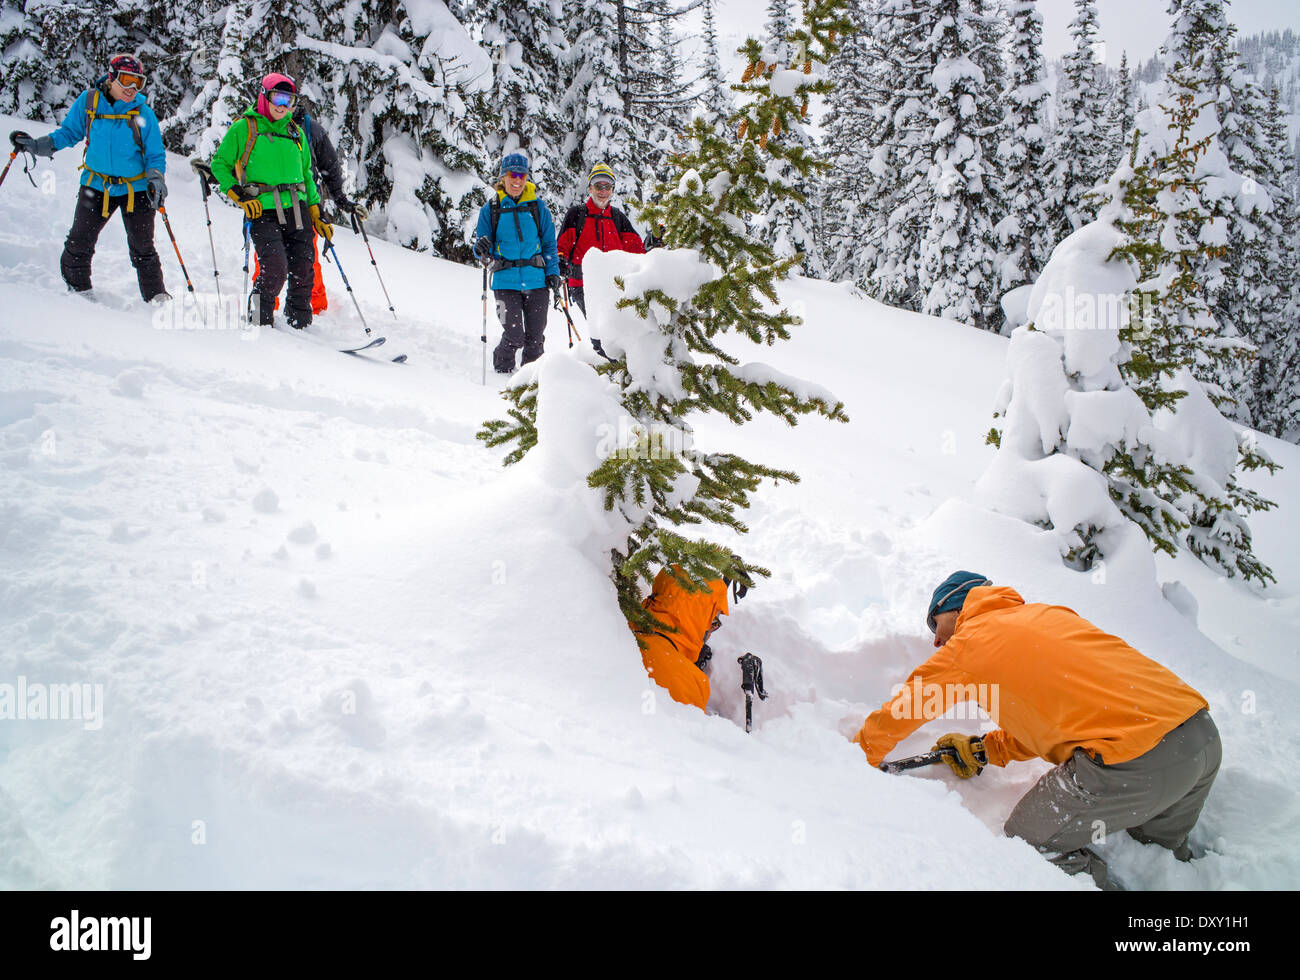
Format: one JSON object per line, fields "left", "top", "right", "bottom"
{"left": 10, "top": 55, "right": 170, "bottom": 302}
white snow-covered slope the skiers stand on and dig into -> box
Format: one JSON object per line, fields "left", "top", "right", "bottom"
{"left": 0, "top": 118, "right": 1300, "bottom": 889}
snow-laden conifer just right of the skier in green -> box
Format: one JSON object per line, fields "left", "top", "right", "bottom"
{"left": 287, "top": 0, "right": 493, "bottom": 259}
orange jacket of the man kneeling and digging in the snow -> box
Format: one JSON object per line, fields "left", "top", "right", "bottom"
{"left": 853, "top": 586, "right": 1209, "bottom": 766}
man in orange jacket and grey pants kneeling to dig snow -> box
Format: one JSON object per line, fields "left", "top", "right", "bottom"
{"left": 854, "top": 572, "right": 1221, "bottom": 888}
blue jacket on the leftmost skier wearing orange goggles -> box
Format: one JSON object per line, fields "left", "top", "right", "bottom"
{"left": 49, "top": 77, "right": 166, "bottom": 196}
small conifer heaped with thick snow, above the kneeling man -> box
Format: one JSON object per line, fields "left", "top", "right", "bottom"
{"left": 976, "top": 146, "right": 1273, "bottom": 584}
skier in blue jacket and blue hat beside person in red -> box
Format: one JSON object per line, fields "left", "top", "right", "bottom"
{"left": 475, "top": 153, "right": 563, "bottom": 374}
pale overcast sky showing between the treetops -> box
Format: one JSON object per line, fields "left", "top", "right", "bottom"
{"left": 716, "top": 0, "right": 1300, "bottom": 69}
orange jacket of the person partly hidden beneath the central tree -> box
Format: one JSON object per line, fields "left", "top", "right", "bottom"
{"left": 637, "top": 568, "right": 728, "bottom": 711}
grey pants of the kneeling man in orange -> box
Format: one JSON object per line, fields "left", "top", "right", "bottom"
{"left": 1005, "top": 708, "right": 1222, "bottom": 888}
